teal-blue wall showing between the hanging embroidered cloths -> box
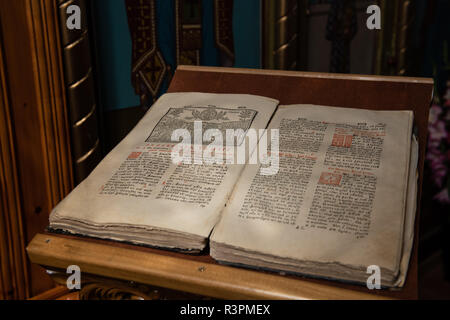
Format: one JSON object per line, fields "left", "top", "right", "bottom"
{"left": 92, "top": 0, "right": 261, "bottom": 111}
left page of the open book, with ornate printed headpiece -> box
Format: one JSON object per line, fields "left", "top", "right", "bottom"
{"left": 50, "top": 93, "right": 278, "bottom": 237}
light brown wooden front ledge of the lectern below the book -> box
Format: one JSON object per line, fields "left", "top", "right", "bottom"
{"left": 27, "top": 234, "right": 392, "bottom": 300}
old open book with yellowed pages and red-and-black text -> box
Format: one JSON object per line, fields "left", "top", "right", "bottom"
{"left": 50, "top": 93, "right": 418, "bottom": 286}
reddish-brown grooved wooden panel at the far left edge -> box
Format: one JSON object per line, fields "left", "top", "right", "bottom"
{"left": 0, "top": 0, "right": 73, "bottom": 298}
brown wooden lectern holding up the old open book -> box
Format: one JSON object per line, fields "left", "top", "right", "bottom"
{"left": 27, "top": 66, "right": 433, "bottom": 299}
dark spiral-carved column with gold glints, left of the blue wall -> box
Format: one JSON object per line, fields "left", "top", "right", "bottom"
{"left": 59, "top": 0, "right": 101, "bottom": 183}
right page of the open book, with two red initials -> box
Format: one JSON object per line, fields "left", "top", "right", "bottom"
{"left": 211, "top": 105, "right": 412, "bottom": 271}
